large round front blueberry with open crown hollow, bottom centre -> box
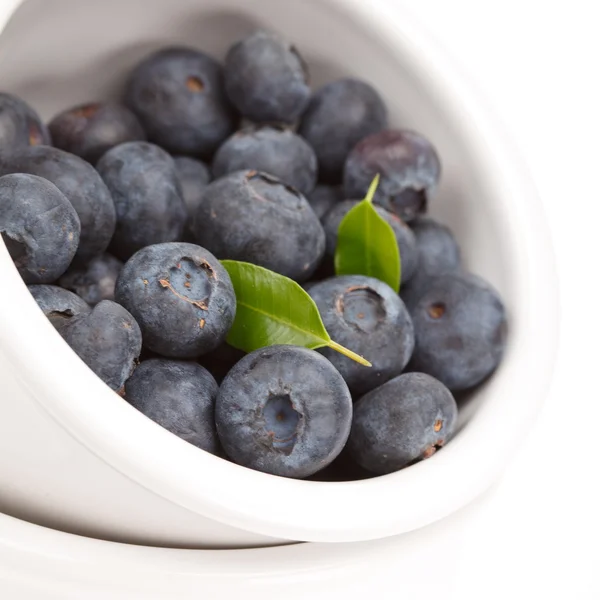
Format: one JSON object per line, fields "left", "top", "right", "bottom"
{"left": 215, "top": 346, "right": 352, "bottom": 478}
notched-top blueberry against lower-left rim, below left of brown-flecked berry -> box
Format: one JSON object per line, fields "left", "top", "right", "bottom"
{"left": 56, "top": 300, "right": 142, "bottom": 392}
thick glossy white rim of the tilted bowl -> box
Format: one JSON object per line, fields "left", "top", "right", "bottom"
{"left": 0, "top": 0, "right": 558, "bottom": 542}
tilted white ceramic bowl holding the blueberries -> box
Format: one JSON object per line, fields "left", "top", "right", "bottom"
{"left": 0, "top": 0, "right": 557, "bottom": 547}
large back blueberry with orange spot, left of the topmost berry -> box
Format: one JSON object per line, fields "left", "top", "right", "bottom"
{"left": 125, "top": 47, "right": 238, "bottom": 159}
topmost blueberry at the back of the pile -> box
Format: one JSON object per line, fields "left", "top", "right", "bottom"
{"left": 225, "top": 30, "right": 310, "bottom": 123}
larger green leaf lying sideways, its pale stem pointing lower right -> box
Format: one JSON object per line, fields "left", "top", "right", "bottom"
{"left": 221, "top": 260, "right": 371, "bottom": 367}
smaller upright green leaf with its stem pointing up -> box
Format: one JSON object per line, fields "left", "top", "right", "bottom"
{"left": 335, "top": 175, "right": 401, "bottom": 292}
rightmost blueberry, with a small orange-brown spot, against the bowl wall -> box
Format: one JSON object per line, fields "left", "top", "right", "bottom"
{"left": 409, "top": 271, "right": 507, "bottom": 392}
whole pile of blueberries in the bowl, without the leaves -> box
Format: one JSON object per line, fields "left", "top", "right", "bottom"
{"left": 0, "top": 31, "right": 506, "bottom": 481}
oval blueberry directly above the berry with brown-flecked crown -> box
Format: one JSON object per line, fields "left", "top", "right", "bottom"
{"left": 97, "top": 142, "right": 188, "bottom": 260}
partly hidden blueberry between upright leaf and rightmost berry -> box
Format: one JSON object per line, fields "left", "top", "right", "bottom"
{"left": 400, "top": 216, "right": 461, "bottom": 309}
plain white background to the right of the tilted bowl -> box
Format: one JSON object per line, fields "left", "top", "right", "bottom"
{"left": 386, "top": 0, "right": 600, "bottom": 600}
